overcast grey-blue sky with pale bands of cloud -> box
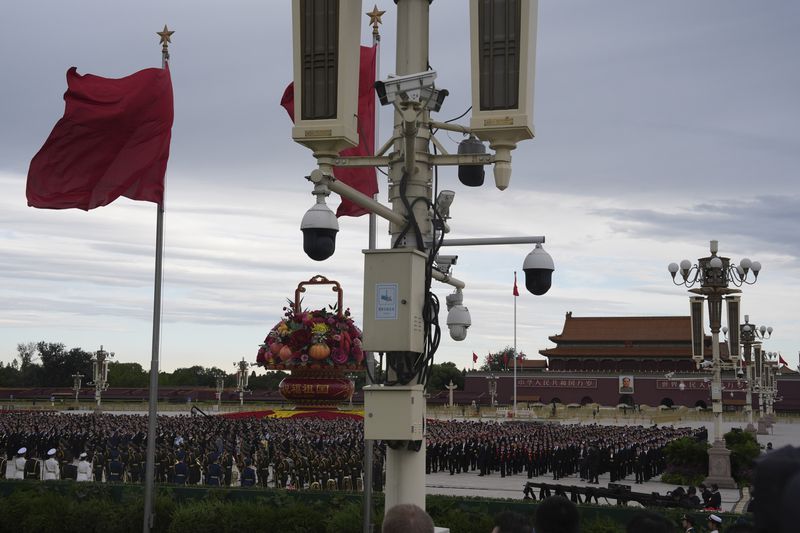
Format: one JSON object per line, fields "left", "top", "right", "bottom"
{"left": 0, "top": 0, "right": 800, "bottom": 371}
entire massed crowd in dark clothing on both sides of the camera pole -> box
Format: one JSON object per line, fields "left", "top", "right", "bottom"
{"left": 0, "top": 412, "right": 706, "bottom": 491}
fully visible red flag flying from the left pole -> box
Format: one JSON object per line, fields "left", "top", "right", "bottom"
{"left": 26, "top": 67, "right": 173, "bottom": 211}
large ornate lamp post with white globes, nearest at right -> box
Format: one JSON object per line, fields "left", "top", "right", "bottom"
{"left": 668, "top": 241, "right": 761, "bottom": 488}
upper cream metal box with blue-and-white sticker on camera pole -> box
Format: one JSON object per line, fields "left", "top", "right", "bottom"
{"left": 362, "top": 248, "right": 427, "bottom": 353}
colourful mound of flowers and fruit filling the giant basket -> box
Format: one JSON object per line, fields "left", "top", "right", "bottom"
{"left": 256, "top": 306, "right": 364, "bottom": 369}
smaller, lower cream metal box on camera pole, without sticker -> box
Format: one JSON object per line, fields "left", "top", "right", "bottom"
{"left": 363, "top": 385, "right": 425, "bottom": 440}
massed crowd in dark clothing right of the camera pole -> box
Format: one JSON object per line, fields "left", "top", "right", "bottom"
{"left": 425, "top": 420, "right": 707, "bottom": 483}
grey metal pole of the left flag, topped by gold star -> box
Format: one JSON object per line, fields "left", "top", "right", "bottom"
{"left": 142, "top": 24, "right": 175, "bottom": 533}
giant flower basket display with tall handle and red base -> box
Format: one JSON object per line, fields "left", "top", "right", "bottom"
{"left": 256, "top": 276, "right": 364, "bottom": 405}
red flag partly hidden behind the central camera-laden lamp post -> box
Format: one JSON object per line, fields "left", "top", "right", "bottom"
{"left": 281, "top": 46, "right": 378, "bottom": 217}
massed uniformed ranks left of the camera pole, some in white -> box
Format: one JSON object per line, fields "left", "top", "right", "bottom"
{"left": 0, "top": 412, "right": 385, "bottom": 490}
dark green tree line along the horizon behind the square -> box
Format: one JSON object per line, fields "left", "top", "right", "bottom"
{"left": 0, "top": 341, "right": 465, "bottom": 392}
